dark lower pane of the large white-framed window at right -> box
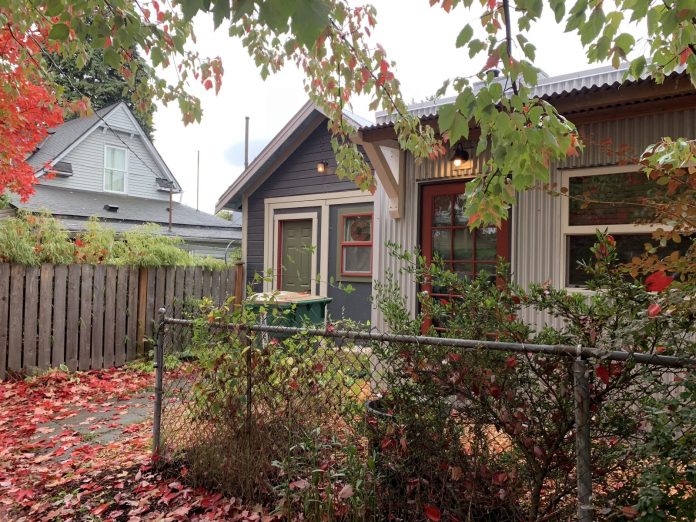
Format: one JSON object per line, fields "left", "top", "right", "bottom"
{"left": 566, "top": 234, "right": 690, "bottom": 287}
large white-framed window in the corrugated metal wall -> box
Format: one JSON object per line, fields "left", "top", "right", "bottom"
{"left": 561, "top": 165, "right": 676, "bottom": 288}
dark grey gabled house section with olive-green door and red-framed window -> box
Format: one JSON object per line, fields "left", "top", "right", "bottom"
{"left": 216, "top": 102, "right": 374, "bottom": 321}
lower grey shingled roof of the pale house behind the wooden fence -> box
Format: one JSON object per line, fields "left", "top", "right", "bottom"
{"left": 13, "top": 185, "right": 241, "bottom": 240}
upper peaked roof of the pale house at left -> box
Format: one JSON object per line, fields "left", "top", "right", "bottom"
{"left": 27, "top": 101, "right": 181, "bottom": 192}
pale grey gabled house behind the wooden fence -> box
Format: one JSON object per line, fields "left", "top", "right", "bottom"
{"left": 13, "top": 102, "right": 242, "bottom": 258}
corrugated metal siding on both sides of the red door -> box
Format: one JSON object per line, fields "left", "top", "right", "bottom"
{"left": 372, "top": 109, "right": 696, "bottom": 329}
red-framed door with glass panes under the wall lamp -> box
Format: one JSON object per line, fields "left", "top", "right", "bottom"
{"left": 421, "top": 182, "right": 510, "bottom": 328}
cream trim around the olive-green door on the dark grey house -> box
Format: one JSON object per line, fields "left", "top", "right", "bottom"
{"left": 262, "top": 190, "right": 376, "bottom": 296}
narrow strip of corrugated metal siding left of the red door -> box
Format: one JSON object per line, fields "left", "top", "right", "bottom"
{"left": 372, "top": 154, "right": 420, "bottom": 331}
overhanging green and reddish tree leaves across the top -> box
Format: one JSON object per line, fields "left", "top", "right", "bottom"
{"left": 0, "top": 0, "right": 696, "bottom": 231}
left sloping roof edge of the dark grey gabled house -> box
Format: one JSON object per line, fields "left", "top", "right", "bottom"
{"left": 215, "top": 100, "right": 372, "bottom": 212}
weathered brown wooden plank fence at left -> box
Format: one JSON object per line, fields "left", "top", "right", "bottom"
{"left": 0, "top": 263, "right": 244, "bottom": 379}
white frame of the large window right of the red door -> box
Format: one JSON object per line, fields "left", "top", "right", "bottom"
{"left": 559, "top": 165, "right": 669, "bottom": 293}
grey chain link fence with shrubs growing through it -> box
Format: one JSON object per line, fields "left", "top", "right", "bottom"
{"left": 154, "top": 318, "right": 696, "bottom": 521}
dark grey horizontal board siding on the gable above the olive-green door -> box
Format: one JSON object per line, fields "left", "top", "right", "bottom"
{"left": 246, "top": 122, "right": 356, "bottom": 281}
